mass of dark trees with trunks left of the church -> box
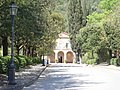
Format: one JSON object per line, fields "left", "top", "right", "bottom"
{"left": 0, "top": 0, "right": 64, "bottom": 72}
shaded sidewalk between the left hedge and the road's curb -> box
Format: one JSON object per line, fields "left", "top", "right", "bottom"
{"left": 0, "top": 64, "right": 46, "bottom": 90}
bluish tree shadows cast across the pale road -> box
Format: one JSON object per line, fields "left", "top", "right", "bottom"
{"left": 24, "top": 65, "right": 103, "bottom": 90}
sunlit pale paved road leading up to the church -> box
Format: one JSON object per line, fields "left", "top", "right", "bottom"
{"left": 23, "top": 64, "right": 120, "bottom": 90}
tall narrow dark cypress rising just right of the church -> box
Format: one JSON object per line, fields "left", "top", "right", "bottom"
{"left": 68, "top": 0, "right": 83, "bottom": 50}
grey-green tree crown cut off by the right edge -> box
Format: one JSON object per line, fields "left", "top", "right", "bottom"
{"left": 103, "top": 3, "right": 120, "bottom": 50}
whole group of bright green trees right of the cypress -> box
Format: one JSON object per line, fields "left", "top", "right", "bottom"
{"left": 76, "top": 0, "right": 120, "bottom": 65}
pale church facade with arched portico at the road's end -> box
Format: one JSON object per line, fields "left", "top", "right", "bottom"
{"left": 49, "top": 32, "right": 75, "bottom": 63}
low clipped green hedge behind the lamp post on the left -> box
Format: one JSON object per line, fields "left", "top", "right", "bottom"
{"left": 0, "top": 56, "right": 41, "bottom": 74}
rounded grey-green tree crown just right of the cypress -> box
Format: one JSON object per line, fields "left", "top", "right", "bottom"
{"left": 77, "top": 24, "right": 106, "bottom": 51}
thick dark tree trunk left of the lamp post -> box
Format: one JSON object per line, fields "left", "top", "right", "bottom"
{"left": 2, "top": 36, "right": 8, "bottom": 56}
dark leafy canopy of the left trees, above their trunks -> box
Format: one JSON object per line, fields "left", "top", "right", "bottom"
{"left": 0, "top": 0, "right": 64, "bottom": 56}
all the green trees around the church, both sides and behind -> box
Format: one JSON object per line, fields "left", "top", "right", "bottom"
{"left": 0, "top": 0, "right": 120, "bottom": 74}
